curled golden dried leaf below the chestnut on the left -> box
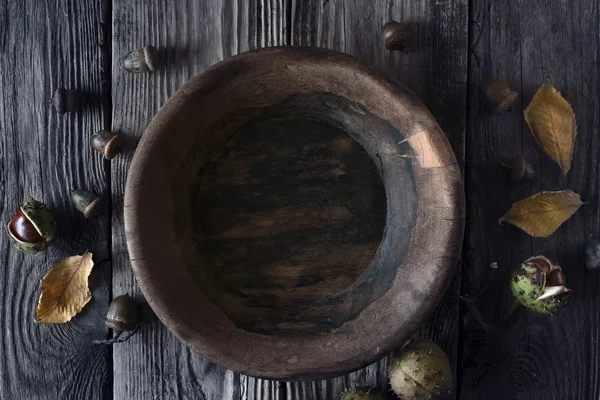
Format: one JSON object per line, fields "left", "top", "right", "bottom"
{"left": 37, "top": 252, "right": 94, "bottom": 324}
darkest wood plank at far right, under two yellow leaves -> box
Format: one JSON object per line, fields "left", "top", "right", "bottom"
{"left": 459, "top": 0, "right": 600, "bottom": 399}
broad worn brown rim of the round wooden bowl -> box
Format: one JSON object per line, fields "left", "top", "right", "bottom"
{"left": 124, "top": 47, "right": 465, "bottom": 380}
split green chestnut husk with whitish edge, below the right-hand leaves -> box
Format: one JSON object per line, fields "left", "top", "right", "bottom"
{"left": 510, "top": 256, "right": 571, "bottom": 314}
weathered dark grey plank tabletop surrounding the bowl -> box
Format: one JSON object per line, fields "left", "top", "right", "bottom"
{"left": 0, "top": 0, "right": 600, "bottom": 400}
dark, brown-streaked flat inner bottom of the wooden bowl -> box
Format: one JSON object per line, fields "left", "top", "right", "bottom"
{"left": 193, "top": 104, "right": 385, "bottom": 334}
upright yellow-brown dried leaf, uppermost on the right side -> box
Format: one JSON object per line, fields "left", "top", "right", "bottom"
{"left": 525, "top": 82, "right": 577, "bottom": 175}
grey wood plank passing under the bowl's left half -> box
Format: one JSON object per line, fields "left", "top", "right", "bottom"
{"left": 112, "top": 0, "right": 287, "bottom": 399}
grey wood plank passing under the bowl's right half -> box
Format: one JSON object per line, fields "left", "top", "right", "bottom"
{"left": 287, "top": 0, "right": 468, "bottom": 399}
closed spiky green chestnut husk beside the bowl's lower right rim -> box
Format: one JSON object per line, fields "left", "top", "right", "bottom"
{"left": 389, "top": 339, "right": 453, "bottom": 399}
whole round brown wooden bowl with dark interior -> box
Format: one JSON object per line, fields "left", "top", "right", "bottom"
{"left": 125, "top": 47, "right": 464, "bottom": 380}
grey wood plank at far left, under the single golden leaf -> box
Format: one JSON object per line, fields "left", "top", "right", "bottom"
{"left": 0, "top": 0, "right": 111, "bottom": 399}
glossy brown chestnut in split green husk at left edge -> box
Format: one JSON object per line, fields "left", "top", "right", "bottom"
{"left": 6, "top": 200, "right": 56, "bottom": 254}
